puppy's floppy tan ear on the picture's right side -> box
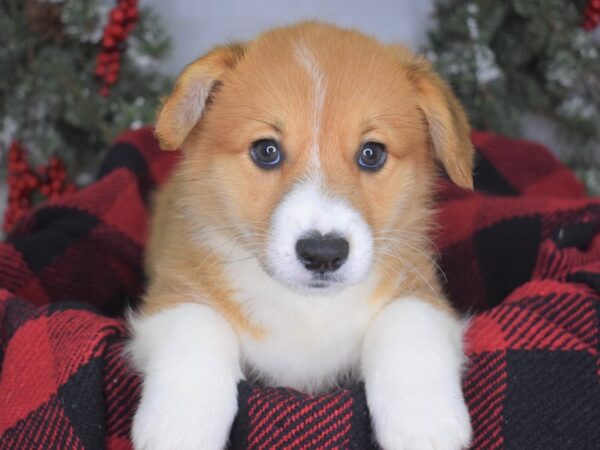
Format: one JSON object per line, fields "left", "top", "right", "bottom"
{"left": 396, "top": 47, "right": 475, "bottom": 189}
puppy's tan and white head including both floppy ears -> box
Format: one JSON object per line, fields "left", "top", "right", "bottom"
{"left": 156, "top": 23, "right": 473, "bottom": 293}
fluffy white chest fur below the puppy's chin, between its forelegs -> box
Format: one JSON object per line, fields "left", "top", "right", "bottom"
{"left": 227, "top": 250, "right": 378, "bottom": 392}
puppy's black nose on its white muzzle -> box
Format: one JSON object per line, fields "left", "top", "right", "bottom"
{"left": 296, "top": 233, "right": 349, "bottom": 272}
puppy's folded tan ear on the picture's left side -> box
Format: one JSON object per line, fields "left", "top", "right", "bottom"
{"left": 155, "top": 44, "right": 245, "bottom": 150}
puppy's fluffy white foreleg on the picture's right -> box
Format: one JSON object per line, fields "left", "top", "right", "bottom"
{"left": 362, "top": 297, "right": 471, "bottom": 450}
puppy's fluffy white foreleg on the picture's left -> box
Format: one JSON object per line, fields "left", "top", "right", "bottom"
{"left": 128, "top": 303, "right": 242, "bottom": 450}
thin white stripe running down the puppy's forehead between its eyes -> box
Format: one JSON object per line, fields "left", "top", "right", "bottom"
{"left": 296, "top": 44, "right": 325, "bottom": 169}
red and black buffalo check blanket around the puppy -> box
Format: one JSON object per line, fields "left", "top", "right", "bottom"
{"left": 0, "top": 129, "right": 600, "bottom": 450}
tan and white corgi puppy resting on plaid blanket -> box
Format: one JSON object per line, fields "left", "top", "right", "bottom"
{"left": 129, "top": 22, "right": 473, "bottom": 450}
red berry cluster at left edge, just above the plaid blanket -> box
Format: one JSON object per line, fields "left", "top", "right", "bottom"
{"left": 3, "top": 141, "right": 75, "bottom": 232}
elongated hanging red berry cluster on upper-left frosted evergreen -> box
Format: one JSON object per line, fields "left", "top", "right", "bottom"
{"left": 96, "top": 0, "right": 139, "bottom": 97}
